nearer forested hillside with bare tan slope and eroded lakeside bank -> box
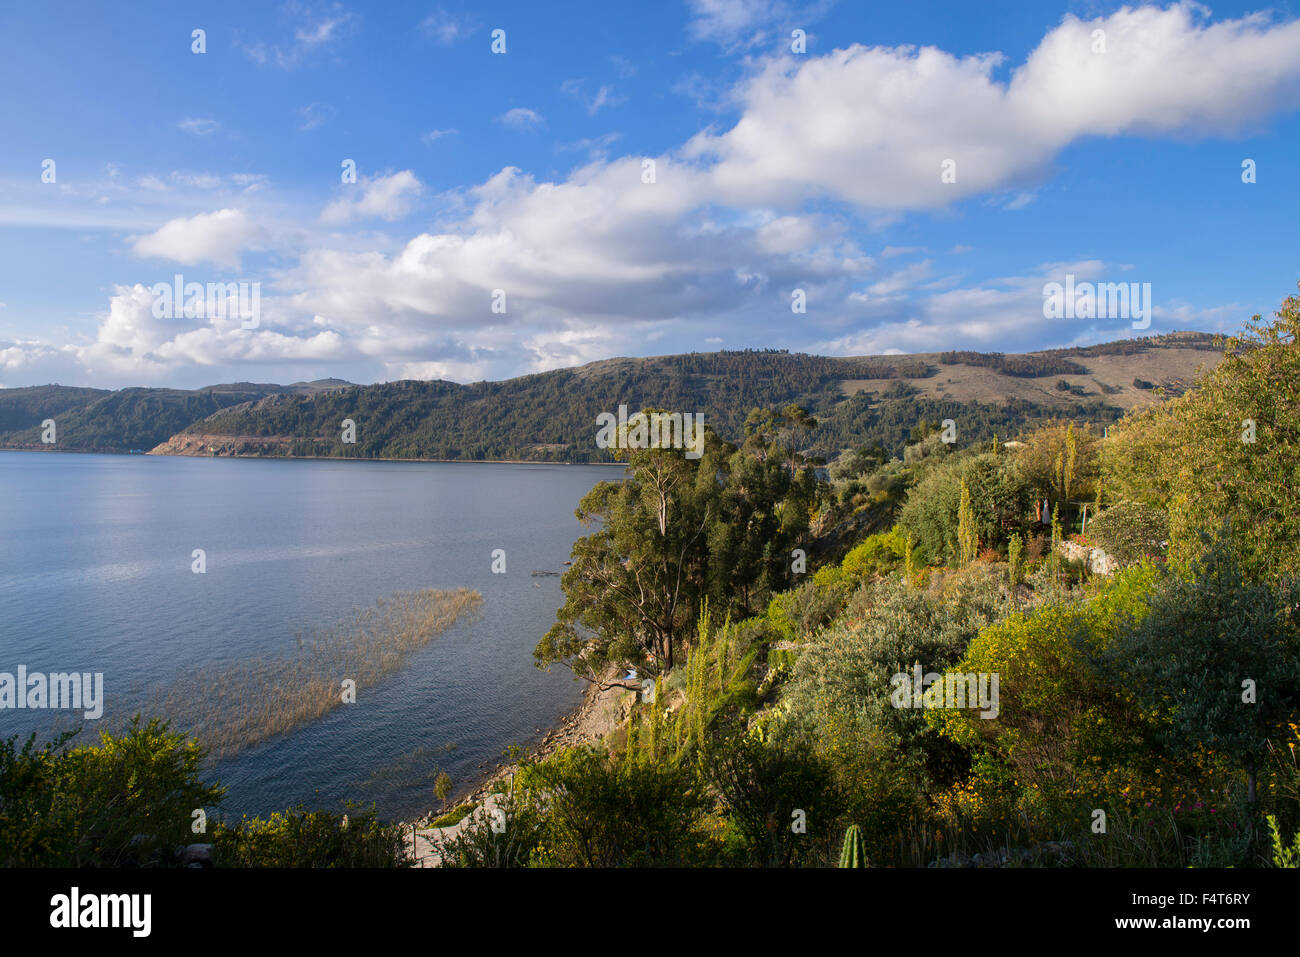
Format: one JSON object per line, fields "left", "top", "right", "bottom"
{"left": 144, "top": 334, "right": 1217, "bottom": 462}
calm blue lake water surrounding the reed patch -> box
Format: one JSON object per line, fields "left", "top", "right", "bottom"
{"left": 0, "top": 451, "right": 621, "bottom": 817}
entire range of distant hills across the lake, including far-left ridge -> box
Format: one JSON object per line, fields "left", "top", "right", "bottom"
{"left": 0, "top": 333, "right": 1219, "bottom": 462}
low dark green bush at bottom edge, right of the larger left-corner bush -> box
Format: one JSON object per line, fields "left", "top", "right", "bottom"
{"left": 212, "top": 804, "right": 413, "bottom": 867}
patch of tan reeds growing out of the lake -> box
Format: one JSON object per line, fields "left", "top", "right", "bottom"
{"left": 152, "top": 588, "right": 482, "bottom": 761}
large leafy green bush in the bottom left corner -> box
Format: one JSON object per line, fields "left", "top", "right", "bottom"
{"left": 0, "top": 718, "right": 224, "bottom": 867}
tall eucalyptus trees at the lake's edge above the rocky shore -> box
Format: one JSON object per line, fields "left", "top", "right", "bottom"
{"left": 533, "top": 421, "right": 815, "bottom": 681}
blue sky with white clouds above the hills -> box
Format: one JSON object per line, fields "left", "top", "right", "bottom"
{"left": 0, "top": 0, "right": 1300, "bottom": 387}
